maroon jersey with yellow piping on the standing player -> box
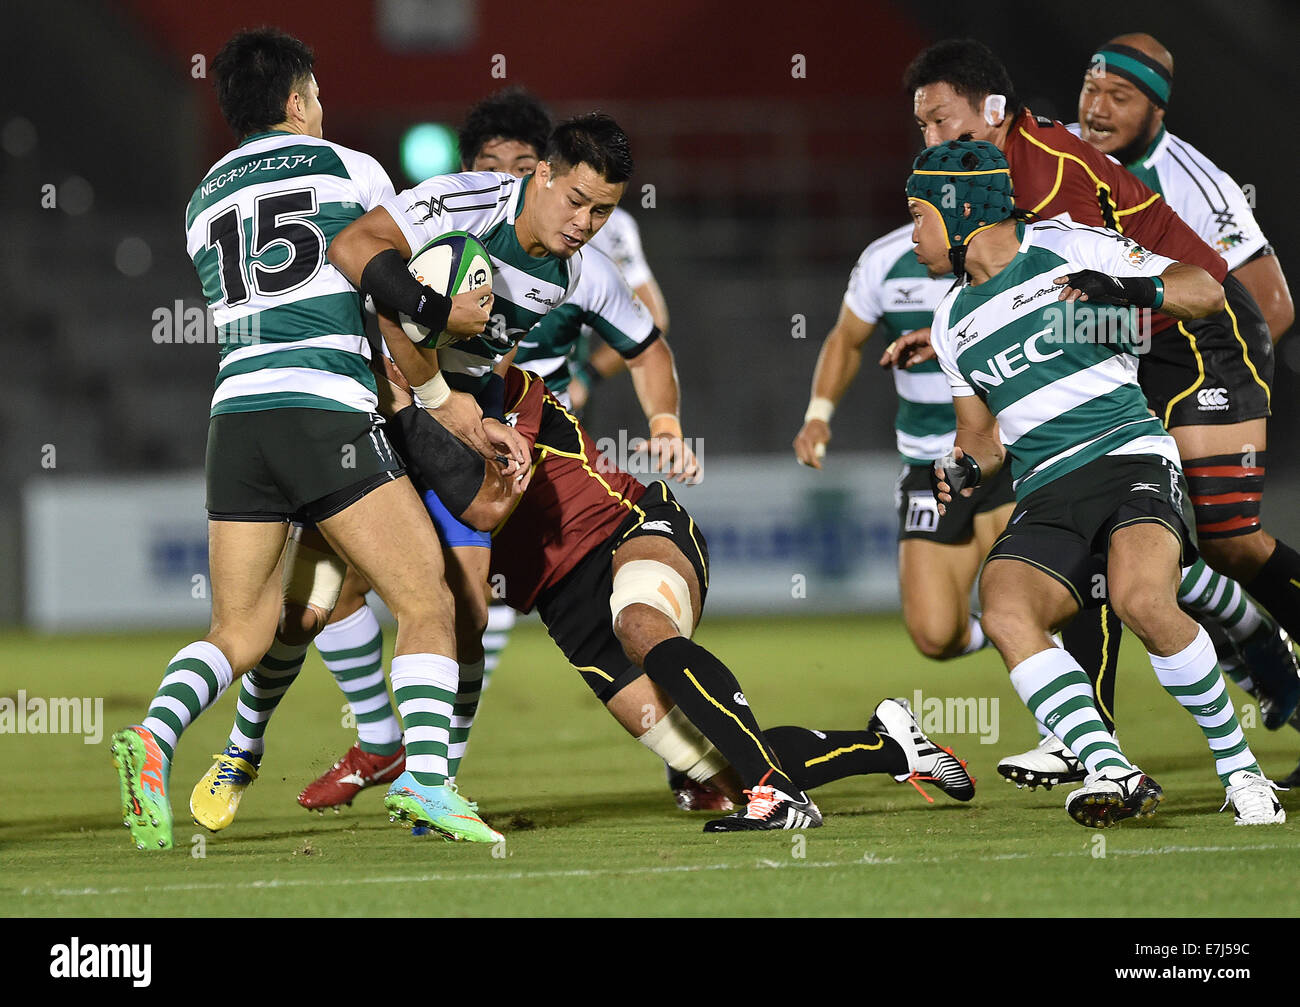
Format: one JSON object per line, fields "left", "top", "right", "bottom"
{"left": 1002, "top": 110, "right": 1227, "bottom": 324}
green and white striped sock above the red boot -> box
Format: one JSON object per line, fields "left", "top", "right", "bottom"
{"left": 316, "top": 605, "right": 402, "bottom": 755}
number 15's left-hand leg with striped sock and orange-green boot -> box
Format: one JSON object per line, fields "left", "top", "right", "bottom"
{"left": 109, "top": 521, "right": 287, "bottom": 850}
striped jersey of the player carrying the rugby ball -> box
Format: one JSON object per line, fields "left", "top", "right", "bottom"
{"left": 384, "top": 172, "right": 582, "bottom": 391}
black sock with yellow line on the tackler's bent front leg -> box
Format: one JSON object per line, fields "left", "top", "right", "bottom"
{"left": 642, "top": 637, "right": 800, "bottom": 798}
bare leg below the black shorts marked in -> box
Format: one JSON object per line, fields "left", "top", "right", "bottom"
{"left": 898, "top": 538, "right": 984, "bottom": 661}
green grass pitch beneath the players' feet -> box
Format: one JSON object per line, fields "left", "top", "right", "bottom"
{"left": 0, "top": 617, "right": 1300, "bottom": 916}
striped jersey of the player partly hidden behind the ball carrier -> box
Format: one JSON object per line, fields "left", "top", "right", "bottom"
{"left": 515, "top": 245, "right": 659, "bottom": 395}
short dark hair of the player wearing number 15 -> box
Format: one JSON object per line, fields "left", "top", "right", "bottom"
{"left": 212, "top": 27, "right": 316, "bottom": 139}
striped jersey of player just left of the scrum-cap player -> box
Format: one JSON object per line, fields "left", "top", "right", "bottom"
{"left": 844, "top": 223, "right": 957, "bottom": 465}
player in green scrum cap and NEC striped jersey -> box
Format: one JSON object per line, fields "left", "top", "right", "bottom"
{"left": 907, "top": 140, "right": 1286, "bottom": 828}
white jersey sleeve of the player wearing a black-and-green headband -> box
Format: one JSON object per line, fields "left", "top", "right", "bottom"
{"left": 1069, "top": 123, "right": 1269, "bottom": 269}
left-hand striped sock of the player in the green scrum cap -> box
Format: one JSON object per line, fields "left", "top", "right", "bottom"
{"left": 1011, "top": 647, "right": 1134, "bottom": 774}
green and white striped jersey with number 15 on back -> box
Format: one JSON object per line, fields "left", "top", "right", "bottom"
{"left": 185, "top": 133, "right": 393, "bottom": 416}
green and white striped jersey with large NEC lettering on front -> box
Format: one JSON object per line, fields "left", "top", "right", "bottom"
{"left": 931, "top": 220, "right": 1182, "bottom": 499}
